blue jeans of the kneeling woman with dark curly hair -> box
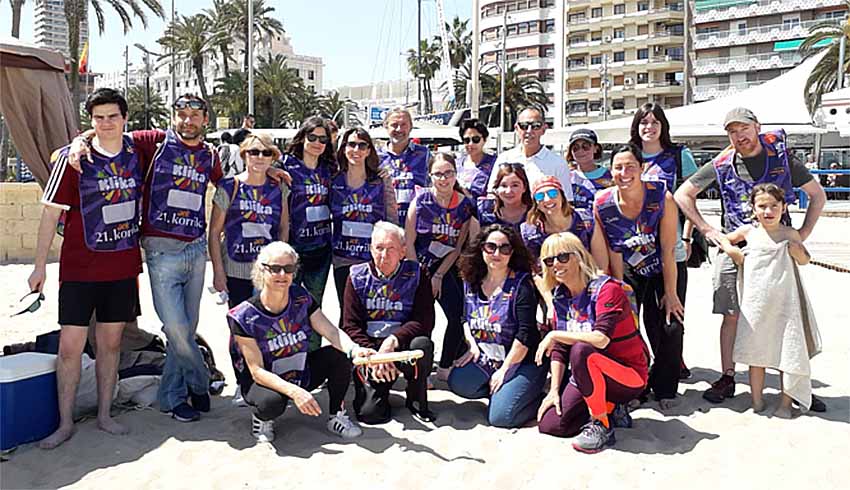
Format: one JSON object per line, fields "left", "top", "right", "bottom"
{"left": 449, "top": 361, "right": 548, "bottom": 429}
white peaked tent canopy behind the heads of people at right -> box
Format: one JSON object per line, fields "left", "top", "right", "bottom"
{"left": 543, "top": 55, "right": 826, "bottom": 145}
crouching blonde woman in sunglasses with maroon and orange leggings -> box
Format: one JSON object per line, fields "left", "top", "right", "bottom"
{"left": 535, "top": 233, "right": 649, "bottom": 453}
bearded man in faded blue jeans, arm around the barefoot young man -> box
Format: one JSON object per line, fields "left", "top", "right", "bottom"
{"left": 68, "top": 95, "right": 222, "bottom": 422}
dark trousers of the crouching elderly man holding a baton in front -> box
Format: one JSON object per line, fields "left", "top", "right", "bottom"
{"left": 354, "top": 337, "right": 434, "bottom": 424}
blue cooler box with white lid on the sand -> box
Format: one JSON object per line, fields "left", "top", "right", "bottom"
{"left": 0, "top": 352, "right": 59, "bottom": 451}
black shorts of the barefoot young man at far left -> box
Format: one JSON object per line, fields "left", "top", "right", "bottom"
{"left": 59, "top": 277, "right": 139, "bottom": 327}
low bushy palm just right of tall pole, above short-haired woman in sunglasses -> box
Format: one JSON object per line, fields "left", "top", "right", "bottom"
{"left": 256, "top": 53, "right": 305, "bottom": 127}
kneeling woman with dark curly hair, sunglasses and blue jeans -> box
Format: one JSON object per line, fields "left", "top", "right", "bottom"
{"left": 449, "top": 224, "right": 546, "bottom": 428}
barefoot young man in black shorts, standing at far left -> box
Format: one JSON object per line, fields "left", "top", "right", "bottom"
{"left": 29, "top": 88, "right": 144, "bottom": 449}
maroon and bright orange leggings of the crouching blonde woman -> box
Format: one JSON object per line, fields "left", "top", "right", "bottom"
{"left": 537, "top": 342, "right": 646, "bottom": 437}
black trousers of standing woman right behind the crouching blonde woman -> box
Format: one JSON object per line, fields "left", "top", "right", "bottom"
{"left": 625, "top": 262, "right": 687, "bottom": 400}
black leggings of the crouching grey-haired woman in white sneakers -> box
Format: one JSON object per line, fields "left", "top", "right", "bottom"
{"left": 242, "top": 346, "right": 351, "bottom": 421}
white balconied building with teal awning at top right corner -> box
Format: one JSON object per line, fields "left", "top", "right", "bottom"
{"left": 690, "top": 0, "right": 847, "bottom": 102}
